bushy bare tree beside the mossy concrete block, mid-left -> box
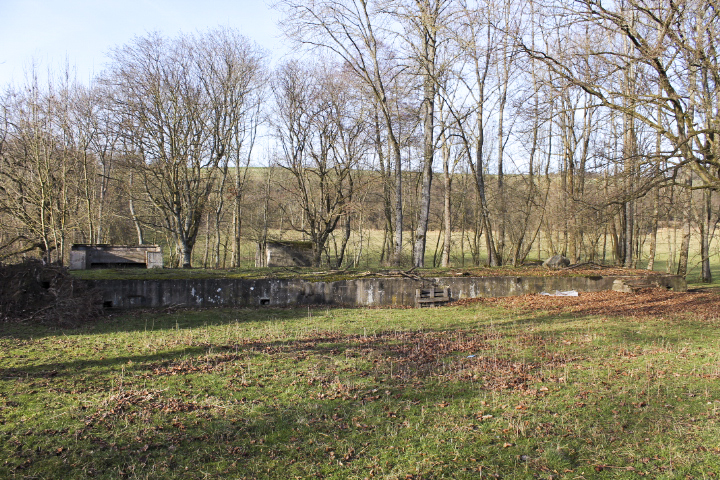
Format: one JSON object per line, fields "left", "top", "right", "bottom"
{"left": 274, "top": 62, "right": 366, "bottom": 266}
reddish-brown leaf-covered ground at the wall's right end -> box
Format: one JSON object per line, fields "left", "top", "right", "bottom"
{"left": 453, "top": 289, "right": 720, "bottom": 320}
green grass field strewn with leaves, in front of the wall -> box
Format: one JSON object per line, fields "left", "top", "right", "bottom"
{"left": 0, "top": 305, "right": 720, "bottom": 479}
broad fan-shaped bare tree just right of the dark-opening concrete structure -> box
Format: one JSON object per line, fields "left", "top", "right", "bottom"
{"left": 103, "top": 29, "right": 263, "bottom": 267}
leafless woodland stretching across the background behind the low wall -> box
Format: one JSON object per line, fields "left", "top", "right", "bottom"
{"left": 0, "top": 0, "right": 720, "bottom": 282}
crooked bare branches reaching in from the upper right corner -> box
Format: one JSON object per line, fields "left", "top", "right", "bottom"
{"left": 518, "top": 0, "right": 720, "bottom": 188}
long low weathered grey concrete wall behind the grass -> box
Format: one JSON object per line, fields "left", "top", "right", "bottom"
{"left": 89, "top": 275, "right": 687, "bottom": 308}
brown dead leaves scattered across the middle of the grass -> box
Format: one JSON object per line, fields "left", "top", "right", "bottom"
{"left": 135, "top": 328, "right": 581, "bottom": 401}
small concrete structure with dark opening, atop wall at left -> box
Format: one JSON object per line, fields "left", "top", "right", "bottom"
{"left": 70, "top": 243, "right": 163, "bottom": 270}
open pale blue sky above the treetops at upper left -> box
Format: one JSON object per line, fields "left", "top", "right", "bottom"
{"left": 0, "top": 0, "right": 286, "bottom": 86}
